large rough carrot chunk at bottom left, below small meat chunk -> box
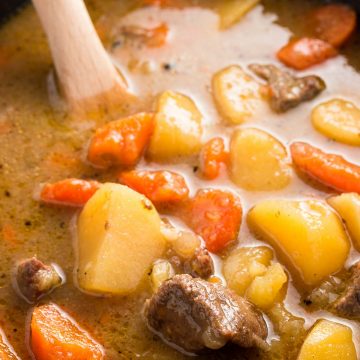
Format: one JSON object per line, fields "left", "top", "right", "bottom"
{"left": 30, "top": 304, "right": 104, "bottom": 360}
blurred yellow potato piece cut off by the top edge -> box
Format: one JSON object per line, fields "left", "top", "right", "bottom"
{"left": 216, "top": 0, "right": 260, "bottom": 29}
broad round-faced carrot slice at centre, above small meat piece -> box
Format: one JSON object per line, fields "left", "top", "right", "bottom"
{"left": 185, "top": 189, "right": 242, "bottom": 253}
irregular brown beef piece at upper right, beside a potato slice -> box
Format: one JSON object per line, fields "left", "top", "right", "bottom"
{"left": 249, "top": 64, "right": 326, "bottom": 113}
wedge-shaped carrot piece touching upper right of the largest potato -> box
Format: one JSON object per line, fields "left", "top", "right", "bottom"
{"left": 119, "top": 170, "right": 189, "bottom": 206}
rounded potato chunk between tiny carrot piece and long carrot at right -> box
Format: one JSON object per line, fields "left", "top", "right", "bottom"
{"left": 230, "top": 128, "right": 291, "bottom": 191}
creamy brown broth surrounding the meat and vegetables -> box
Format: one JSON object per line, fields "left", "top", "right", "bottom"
{"left": 0, "top": 0, "right": 360, "bottom": 360}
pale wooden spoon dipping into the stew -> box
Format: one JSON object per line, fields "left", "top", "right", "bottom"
{"left": 33, "top": 0, "right": 129, "bottom": 113}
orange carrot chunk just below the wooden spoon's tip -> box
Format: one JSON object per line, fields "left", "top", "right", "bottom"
{"left": 87, "top": 113, "right": 155, "bottom": 168}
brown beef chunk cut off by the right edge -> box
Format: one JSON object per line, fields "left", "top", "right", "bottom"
{"left": 333, "top": 261, "right": 360, "bottom": 318}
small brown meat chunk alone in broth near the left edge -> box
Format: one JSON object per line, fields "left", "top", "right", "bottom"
{"left": 16, "top": 257, "right": 63, "bottom": 303}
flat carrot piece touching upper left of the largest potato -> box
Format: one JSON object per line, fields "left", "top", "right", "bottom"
{"left": 40, "top": 179, "right": 100, "bottom": 206}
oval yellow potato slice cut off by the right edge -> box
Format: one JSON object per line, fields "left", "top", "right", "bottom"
{"left": 311, "top": 99, "right": 360, "bottom": 146}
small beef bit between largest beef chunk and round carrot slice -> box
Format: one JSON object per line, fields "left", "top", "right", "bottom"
{"left": 184, "top": 247, "right": 214, "bottom": 279}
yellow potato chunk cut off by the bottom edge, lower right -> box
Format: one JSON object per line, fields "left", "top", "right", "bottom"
{"left": 297, "top": 320, "right": 357, "bottom": 360}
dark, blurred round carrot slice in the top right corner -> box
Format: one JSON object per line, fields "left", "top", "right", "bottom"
{"left": 309, "top": 4, "right": 356, "bottom": 47}
